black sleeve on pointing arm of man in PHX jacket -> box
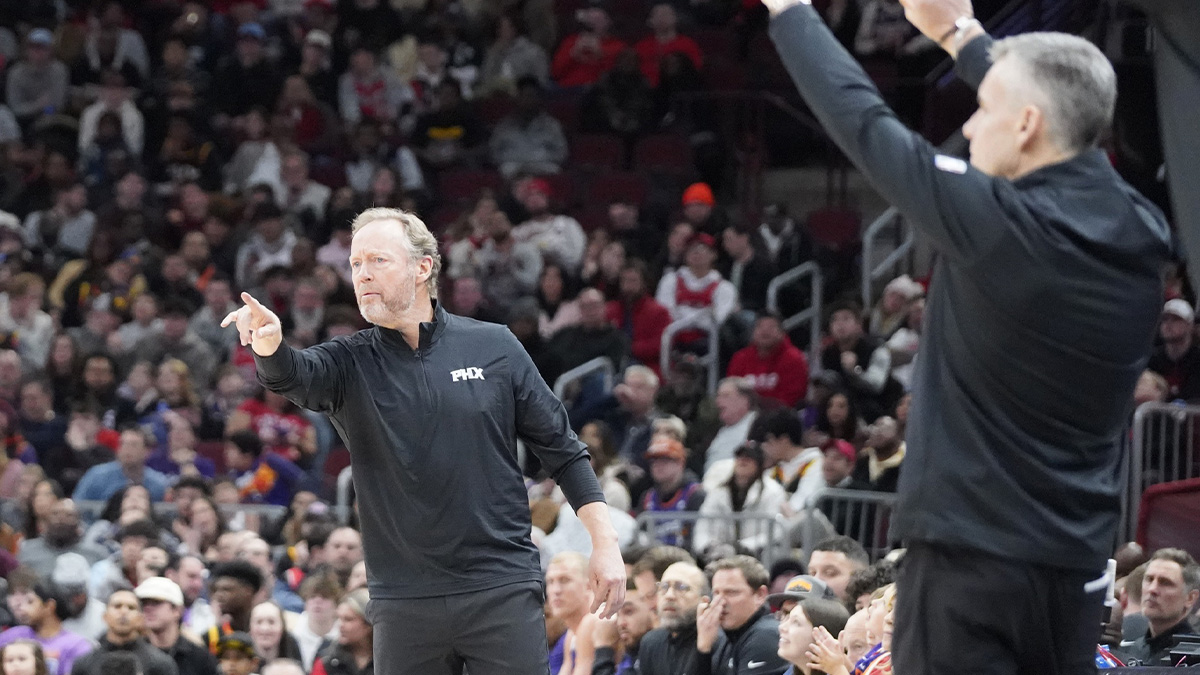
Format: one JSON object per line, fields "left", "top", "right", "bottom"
{"left": 254, "top": 341, "right": 349, "bottom": 413}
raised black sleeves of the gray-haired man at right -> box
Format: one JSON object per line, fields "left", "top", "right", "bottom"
{"left": 770, "top": 5, "right": 1007, "bottom": 259}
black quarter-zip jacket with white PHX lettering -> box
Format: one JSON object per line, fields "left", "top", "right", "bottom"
{"left": 256, "top": 303, "right": 604, "bottom": 599}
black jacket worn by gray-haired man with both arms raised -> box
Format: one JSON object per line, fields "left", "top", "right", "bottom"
{"left": 770, "top": 5, "right": 1174, "bottom": 574}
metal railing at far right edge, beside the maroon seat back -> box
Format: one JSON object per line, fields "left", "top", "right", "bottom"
{"left": 1122, "top": 402, "right": 1200, "bottom": 538}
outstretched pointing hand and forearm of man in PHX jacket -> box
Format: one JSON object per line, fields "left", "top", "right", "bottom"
{"left": 221, "top": 293, "right": 343, "bottom": 412}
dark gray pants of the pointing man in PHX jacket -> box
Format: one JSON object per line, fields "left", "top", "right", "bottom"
{"left": 367, "top": 581, "right": 550, "bottom": 675}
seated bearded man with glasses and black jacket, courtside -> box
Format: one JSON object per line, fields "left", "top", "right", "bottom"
{"left": 637, "top": 562, "right": 708, "bottom": 675}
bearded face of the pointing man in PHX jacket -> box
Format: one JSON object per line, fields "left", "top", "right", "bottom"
{"left": 350, "top": 220, "right": 430, "bottom": 328}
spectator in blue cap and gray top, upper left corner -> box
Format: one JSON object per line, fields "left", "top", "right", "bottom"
{"left": 5, "top": 28, "right": 71, "bottom": 127}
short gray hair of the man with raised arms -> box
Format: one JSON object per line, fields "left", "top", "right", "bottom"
{"left": 991, "top": 32, "right": 1117, "bottom": 153}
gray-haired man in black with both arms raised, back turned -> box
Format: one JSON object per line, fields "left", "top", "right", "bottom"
{"left": 766, "top": 0, "right": 1172, "bottom": 675}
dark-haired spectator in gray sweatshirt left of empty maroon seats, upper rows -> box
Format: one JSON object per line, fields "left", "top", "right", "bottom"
{"left": 488, "top": 77, "right": 566, "bottom": 178}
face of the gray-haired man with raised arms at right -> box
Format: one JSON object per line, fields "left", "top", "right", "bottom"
{"left": 962, "top": 58, "right": 1044, "bottom": 179}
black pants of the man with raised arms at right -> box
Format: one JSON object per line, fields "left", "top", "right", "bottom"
{"left": 892, "top": 543, "right": 1105, "bottom": 675}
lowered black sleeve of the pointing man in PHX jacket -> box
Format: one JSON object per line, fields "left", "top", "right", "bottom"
{"left": 504, "top": 330, "right": 605, "bottom": 510}
